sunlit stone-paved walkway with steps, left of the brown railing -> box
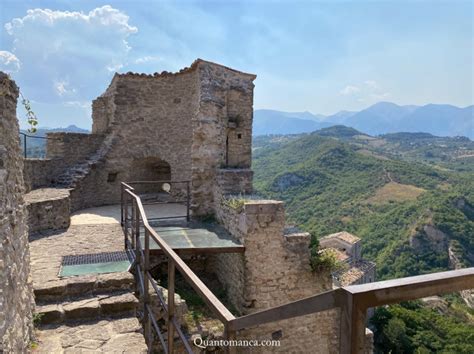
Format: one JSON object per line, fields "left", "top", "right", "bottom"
{"left": 30, "top": 206, "right": 146, "bottom": 353}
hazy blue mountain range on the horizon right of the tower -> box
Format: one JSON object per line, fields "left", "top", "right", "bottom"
{"left": 253, "top": 102, "right": 474, "bottom": 139}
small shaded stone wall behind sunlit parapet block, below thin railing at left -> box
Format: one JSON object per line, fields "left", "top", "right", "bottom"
{"left": 23, "top": 158, "right": 61, "bottom": 192}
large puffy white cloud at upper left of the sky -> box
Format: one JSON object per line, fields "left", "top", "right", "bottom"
{"left": 5, "top": 5, "right": 138, "bottom": 102}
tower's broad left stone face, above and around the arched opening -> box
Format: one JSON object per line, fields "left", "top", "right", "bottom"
{"left": 77, "top": 67, "right": 199, "bottom": 206}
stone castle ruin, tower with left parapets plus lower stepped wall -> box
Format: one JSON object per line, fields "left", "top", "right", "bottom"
{"left": 15, "top": 60, "right": 348, "bottom": 352}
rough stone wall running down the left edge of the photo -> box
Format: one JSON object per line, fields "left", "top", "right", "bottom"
{"left": 0, "top": 72, "right": 34, "bottom": 353}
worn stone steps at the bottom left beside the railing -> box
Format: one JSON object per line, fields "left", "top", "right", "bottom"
{"left": 34, "top": 272, "right": 147, "bottom": 353}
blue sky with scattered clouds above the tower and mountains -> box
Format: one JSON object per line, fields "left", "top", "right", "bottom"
{"left": 0, "top": 0, "right": 474, "bottom": 128}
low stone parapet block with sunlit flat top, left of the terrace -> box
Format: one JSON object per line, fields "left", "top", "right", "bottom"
{"left": 25, "top": 188, "right": 71, "bottom": 233}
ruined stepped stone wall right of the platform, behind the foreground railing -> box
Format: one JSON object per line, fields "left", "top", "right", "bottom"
{"left": 207, "top": 196, "right": 340, "bottom": 353}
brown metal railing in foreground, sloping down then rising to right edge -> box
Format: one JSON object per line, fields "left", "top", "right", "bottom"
{"left": 122, "top": 183, "right": 474, "bottom": 354}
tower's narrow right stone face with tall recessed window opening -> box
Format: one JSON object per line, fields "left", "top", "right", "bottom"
{"left": 191, "top": 61, "right": 256, "bottom": 215}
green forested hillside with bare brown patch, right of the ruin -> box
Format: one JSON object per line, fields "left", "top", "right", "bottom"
{"left": 253, "top": 127, "right": 474, "bottom": 352}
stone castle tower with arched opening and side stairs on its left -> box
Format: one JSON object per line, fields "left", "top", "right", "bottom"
{"left": 27, "top": 60, "right": 255, "bottom": 215}
